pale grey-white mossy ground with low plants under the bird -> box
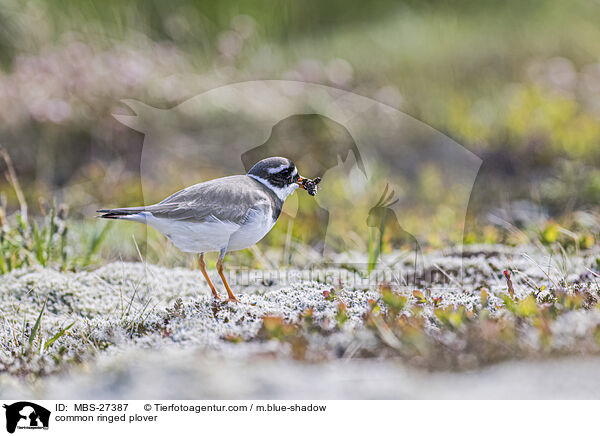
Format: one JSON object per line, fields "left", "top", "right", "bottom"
{"left": 0, "top": 246, "right": 600, "bottom": 399}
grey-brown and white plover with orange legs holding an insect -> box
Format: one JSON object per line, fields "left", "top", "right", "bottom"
{"left": 97, "top": 157, "right": 321, "bottom": 301}
